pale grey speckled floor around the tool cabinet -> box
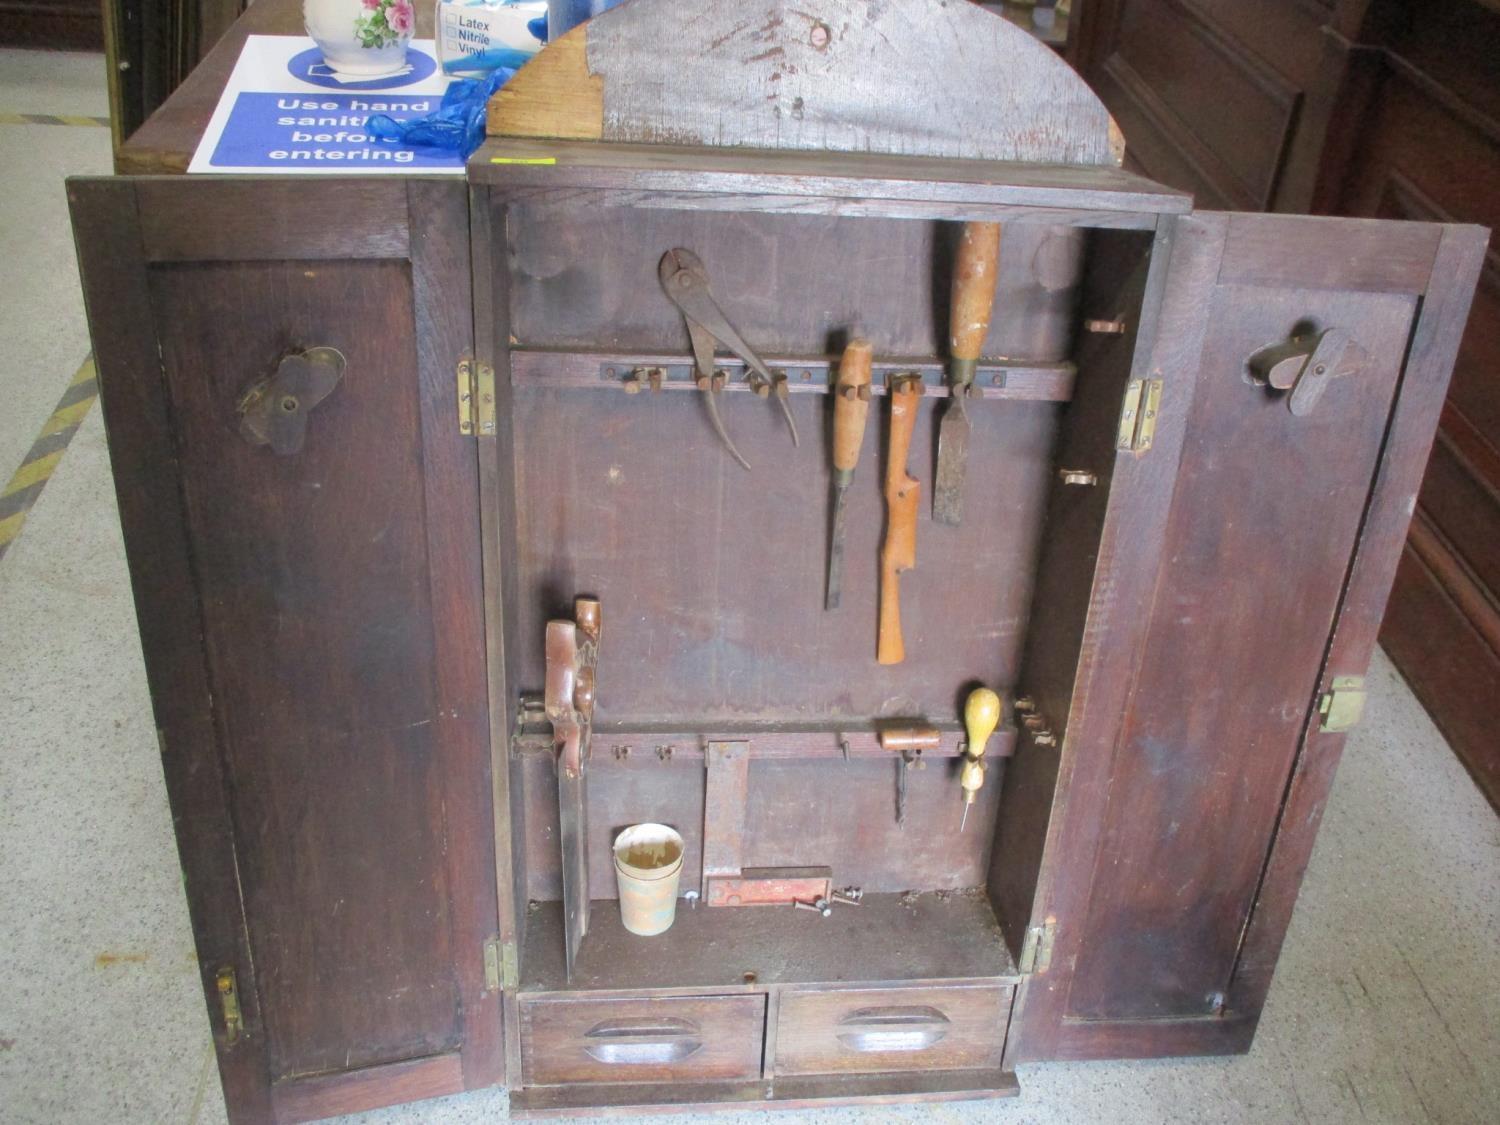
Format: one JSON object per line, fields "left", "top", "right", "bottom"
{"left": 0, "top": 41, "right": 1500, "bottom": 1125}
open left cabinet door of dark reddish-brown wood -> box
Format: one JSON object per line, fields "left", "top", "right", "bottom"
{"left": 69, "top": 179, "right": 503, "bottom": 1122}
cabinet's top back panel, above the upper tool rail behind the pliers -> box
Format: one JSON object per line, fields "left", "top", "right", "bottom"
{"left": 510, "top": 203, "right": 1085, "bottom": 360}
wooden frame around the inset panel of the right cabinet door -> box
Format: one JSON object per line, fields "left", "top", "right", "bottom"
{"left": 1007, "top": 213, "right": 1487, "bottom": 1064}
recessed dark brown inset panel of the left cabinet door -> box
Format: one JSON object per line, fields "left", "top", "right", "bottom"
{"left": 152, "top": 261, "right": 462, "bottom": 1079}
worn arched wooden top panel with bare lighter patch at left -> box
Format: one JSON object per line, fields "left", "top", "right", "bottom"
{"left": 489, "top": 0, "right": 1124, "bottom": 165}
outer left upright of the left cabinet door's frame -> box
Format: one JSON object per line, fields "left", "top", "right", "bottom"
{"left": 68, "top": 180, "right": 272, "bottom": 1121}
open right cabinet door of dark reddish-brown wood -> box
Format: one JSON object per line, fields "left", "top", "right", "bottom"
{"left": 1010, "top": 215, "right": 1485, "bottom": 1062}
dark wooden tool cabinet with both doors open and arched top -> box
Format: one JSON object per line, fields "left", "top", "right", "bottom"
{"left": 71, "top": 0, "right": 1485, "bottom": 1122}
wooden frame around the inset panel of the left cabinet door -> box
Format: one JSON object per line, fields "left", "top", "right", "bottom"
{"left": 68, "top": 177, "right": 506, "bottom": 1122}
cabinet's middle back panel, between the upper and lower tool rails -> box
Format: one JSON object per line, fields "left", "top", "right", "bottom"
{"left": 513, "top": 389, "right": 1058, "bottom": 728}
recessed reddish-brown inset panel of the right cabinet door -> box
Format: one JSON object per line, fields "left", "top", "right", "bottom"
{"left": 1070, "top": 280, "right": 1415, "bottom": 1020}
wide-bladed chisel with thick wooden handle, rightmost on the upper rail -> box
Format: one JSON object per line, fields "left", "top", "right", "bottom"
{"left": 933, "top": 222, "right": 1001, "bottom": 527}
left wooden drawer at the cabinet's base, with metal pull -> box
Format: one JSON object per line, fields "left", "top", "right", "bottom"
{"left": 521, "top": 996, "right": 765, "bottom": 1086}
